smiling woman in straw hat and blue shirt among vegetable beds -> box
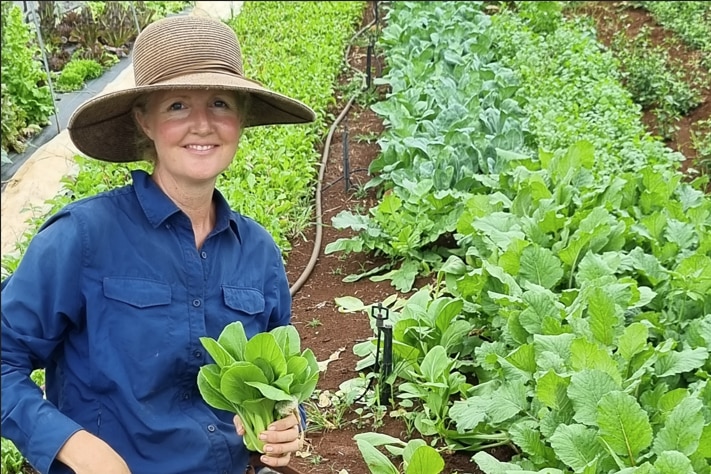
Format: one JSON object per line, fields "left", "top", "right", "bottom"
{"left": 2, "top": 12, "right": 315, "bottom": 474}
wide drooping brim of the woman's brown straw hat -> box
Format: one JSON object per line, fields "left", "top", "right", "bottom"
{"left": 67, "top": 72, "right": 316, "bottom": 162}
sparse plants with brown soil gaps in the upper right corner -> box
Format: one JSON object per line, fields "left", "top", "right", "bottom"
{"left": 569, "top": 2, "right": 711, "bottom": 177}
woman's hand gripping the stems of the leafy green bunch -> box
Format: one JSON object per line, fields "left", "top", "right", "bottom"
{"left": 234, "top": 414, "right": 303, "bottom": 467}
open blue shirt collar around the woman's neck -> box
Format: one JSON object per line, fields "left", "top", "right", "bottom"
{"left": 131, "top": 170, "right": 239, "bottom": 238}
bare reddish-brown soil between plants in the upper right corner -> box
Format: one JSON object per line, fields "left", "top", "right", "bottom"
{"left": 577, "top": 1, "right": 711, "bottom": 184}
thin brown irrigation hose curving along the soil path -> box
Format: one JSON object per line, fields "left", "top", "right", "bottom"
{"left": 289, "top": 16, "right": 382, "bottom": 297}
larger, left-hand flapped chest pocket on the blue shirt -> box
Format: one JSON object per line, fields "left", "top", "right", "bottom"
{"left": 102, "top": 277, "right": 172, "bottom": 364}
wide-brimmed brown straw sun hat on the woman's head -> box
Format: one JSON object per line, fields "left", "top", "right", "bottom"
{"left": 67, "top": 16, "right": 315, "bottom": 162}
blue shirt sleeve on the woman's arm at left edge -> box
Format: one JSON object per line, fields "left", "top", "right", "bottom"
{"left": 1, "top": 211, "right": 83, "bottom": 472}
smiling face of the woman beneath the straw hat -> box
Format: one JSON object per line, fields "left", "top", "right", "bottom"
{"left": 137, "top": 90, "right": 242, "bottom": 183}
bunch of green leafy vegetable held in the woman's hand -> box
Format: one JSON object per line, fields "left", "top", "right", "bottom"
{"left": 197, "top": 321, "right": 319, "bottom": 453}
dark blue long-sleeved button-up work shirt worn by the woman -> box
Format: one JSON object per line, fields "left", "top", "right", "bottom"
{"left": 2, "top": 171, "right": 291, "bottom": 474}
